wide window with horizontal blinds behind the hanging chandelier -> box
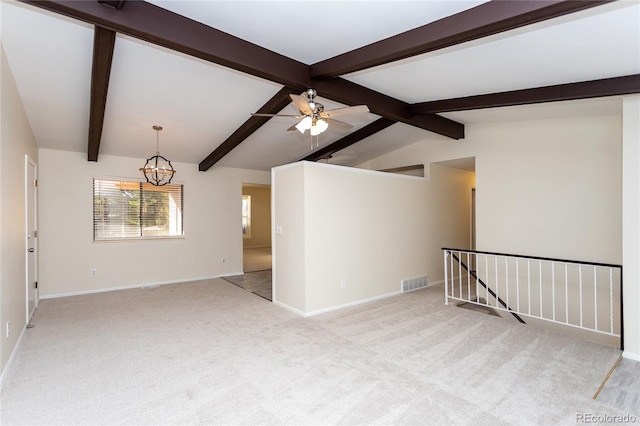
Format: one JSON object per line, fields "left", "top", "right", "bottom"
{"left": 93, "top": 179, "right": 184, "bottom": 241}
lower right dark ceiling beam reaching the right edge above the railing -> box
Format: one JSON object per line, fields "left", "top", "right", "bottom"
{"left": 410, "top": 74, "right": 640, "bottom": 114}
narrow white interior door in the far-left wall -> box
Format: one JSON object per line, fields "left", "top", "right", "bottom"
{"left": 24, "top": 156, "right": 38, "bottom": 323}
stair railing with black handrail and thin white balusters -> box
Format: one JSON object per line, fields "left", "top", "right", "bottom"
{"left": 443, "top": 248, "right": 624, "bottom": 349}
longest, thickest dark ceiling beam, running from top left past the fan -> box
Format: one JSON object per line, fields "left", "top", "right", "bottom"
{"left": 20, "top": 0, "right": 464, "bottom": 150}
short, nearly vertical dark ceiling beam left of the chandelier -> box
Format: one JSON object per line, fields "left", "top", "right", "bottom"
{"left": 87, "top": 27, "right": 116, "bottom": 161}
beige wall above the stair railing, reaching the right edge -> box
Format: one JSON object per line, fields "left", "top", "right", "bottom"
{"left": 362, "top": 110, "right": 640, "bottom": 358}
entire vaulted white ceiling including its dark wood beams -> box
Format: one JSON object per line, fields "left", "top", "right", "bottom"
{"left": 1, "top": 0, "right": 640, "bottom": 171}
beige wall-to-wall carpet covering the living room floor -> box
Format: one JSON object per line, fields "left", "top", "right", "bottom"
{"left": 1, "top": 279, "right": 626, "bottom": 425}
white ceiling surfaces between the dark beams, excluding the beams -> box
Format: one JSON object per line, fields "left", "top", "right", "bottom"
{"left": 0, "top": 0, "right": 640, "bottom": 170}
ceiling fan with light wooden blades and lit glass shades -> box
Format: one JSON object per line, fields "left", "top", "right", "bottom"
{"left": 251, "top": 89, "right": 369, "bottom": 136}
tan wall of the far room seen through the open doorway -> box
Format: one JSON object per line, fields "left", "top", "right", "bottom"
{"left": 242, "top": 185, "right": 271, "bottom": 248}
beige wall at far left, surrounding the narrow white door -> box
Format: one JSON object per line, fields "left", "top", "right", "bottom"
{"left": 0, "top": 45, "right": 38, "bottom": 377}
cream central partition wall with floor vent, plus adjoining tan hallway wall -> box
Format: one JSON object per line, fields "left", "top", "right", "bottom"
{"left": 272, "top": 163, "right": 473, "bottom": 315}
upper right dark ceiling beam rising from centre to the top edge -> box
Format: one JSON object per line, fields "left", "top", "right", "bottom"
{"left": 309, "top": 0, "right": 613, "bottom": 79}
